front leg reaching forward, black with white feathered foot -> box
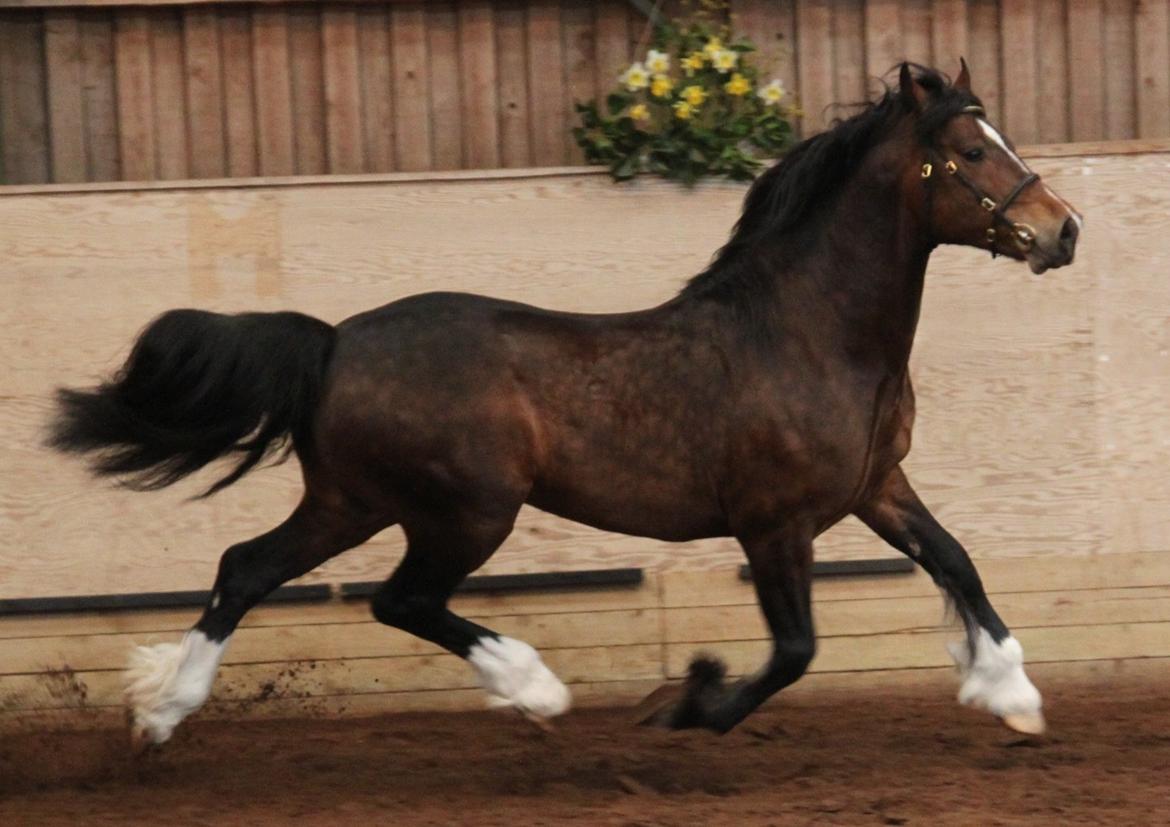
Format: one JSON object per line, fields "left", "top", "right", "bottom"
{"left": 856, "top": 468, "right": 1045, "bottom": 733}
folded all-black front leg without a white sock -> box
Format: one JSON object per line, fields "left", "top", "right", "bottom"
{"left": 648, "top": 532, "right": 817, "bottom": 732}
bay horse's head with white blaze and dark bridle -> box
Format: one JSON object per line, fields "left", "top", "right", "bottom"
{"left": 899, "top": 61, "right": 1082, "bottom": 273}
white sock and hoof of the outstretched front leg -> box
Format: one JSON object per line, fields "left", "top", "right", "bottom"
{"left": 947, "top": 629, "right": 1044, "bottom": 735}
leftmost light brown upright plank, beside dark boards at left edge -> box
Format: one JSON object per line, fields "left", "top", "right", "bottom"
{"left": 44, "top": 9, "right": 87, "bottom": 181}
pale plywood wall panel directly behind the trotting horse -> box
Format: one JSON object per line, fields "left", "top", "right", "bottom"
{"left": 0, "top": 145, "right": 1170, "bottom": 598}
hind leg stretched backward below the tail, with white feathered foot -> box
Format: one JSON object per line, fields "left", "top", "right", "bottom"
{"left": 126, "top": 498, "right": 384, "bottom": 744}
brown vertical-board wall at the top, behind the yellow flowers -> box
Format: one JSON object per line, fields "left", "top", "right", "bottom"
{"left": 0, "top": 0, "right": 1170, "bottom": 184}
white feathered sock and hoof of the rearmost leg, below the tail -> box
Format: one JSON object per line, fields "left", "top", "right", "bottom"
{"left": 125, "top": 632, "right": 227, "bottom": 744}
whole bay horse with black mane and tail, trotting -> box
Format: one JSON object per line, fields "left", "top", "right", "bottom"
{"left": 50, "top": 63, "right": 1081, "bottom": 743}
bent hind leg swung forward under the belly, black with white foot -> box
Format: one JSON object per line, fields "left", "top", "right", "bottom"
{"left": 371, "top": 512, "right": 570, "bottom": 719}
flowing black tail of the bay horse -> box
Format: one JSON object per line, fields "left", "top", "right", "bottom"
{"left": 49, "top": 310, "right": 335, "bottom": 497}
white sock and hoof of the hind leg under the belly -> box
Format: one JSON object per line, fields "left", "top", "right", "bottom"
{"left": 467, "top": 638, "right": 571, "bottom": 718}
